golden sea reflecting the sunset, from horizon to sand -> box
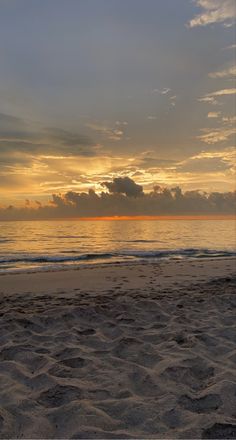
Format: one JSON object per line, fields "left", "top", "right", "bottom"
{"left": 0, "top": 220, "right": 236, "bottom": 272}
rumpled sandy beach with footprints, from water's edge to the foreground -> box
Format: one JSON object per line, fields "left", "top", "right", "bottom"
{"left": 0, "top": 259, "right": 236, "bottom": 439}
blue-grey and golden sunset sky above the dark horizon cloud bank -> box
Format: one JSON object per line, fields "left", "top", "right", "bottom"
{"left": 0, "top": 0, "right": 236, "bottom": 217}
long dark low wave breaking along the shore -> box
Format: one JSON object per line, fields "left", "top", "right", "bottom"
{"left": 0, "top": 248, "right": 236, "bottom": 265}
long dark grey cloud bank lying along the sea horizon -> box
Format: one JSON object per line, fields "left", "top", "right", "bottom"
{"left": 0, "top": 179, "right": 236, "bottom": 220}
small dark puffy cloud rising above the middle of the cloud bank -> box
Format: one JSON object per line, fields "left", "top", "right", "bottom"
{"left": 102, "top": 177, "right": 143, "bottom": 197}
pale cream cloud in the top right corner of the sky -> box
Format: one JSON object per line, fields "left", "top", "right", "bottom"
{"left": 188, "top": 0, "right": 236, "bottom": 28}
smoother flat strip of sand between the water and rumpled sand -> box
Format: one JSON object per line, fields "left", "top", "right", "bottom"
{"left": 0, "top": 257, "right": 236, "bottom": 295}
